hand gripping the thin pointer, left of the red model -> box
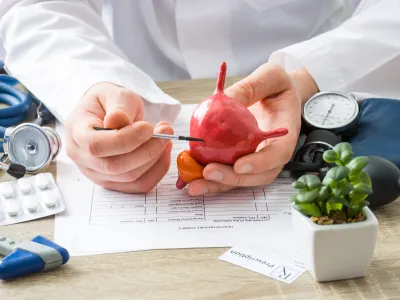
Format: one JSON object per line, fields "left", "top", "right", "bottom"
{"left": 65, "top": 82, "right": 174, "bottom": 193}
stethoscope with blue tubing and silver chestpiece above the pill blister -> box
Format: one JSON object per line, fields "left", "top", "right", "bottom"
{"left": 0, "top": 65, "right": 61, "bottom": 178}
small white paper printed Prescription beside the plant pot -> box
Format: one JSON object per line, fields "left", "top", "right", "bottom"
{"left": 220, "top": 212, "right": 306, "bottom": 284}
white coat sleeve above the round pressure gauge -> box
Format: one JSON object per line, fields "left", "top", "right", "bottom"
{"left": 269, "top": 0, "right": 400, "bottom": 99}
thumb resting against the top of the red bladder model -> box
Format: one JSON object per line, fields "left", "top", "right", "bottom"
{"left": 225, "top": 63, "right": 292, "bottom": 107}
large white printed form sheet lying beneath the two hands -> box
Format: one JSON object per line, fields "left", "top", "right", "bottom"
{"left": 54, "top": 105, "right": 293, "bottom": 256}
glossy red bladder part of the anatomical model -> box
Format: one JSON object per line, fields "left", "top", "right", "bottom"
{"left": 178, "top": 62, "right": 288, "bottom": 188}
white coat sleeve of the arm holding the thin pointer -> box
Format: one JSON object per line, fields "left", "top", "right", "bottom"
{"left": 0, "top": 0, "right": 180, "bottom": 123}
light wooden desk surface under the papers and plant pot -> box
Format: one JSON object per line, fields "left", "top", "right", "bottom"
{"left": 0, "top": 78, "right": 400, "bottom": 300}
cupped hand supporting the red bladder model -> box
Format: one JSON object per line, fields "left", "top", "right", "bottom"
{"left": 188, "top": 63, "right": 318, "bottom": 195}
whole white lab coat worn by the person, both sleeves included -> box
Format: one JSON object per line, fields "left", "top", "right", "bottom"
{"left": 0, "top": 0, "right": 400, "bottom": 122}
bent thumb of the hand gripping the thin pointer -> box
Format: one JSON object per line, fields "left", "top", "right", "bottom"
{"left": 102, "top": 88, "right": 144, "bottom": 129}
